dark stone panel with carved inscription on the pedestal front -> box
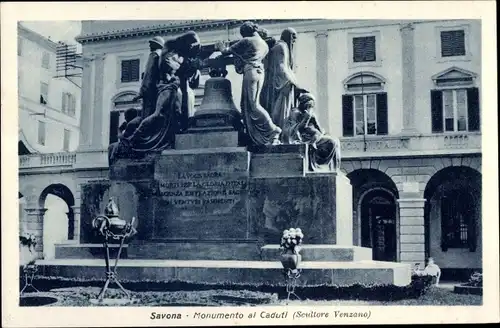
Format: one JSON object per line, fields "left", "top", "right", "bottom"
{"left": 154, "top": 152, "right": 248, "bottom": 240}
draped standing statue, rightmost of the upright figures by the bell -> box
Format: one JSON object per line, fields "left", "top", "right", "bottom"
{"left": 260, "top": 28, "right": 304, "bottom": 128}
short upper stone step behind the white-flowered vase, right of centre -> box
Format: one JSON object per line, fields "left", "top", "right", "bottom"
{"left": 261, "top": 244, "right": 372, "bottom": 262}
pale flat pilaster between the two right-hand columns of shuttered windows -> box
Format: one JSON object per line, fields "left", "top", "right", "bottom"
{"left": 400, "top": 24, "right": 416, "bottom": 134}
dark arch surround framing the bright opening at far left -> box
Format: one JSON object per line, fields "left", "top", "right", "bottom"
{"left": 38, "top": 183, "right": 75, "bottom": 253}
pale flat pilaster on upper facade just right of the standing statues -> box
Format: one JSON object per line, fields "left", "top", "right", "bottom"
{"left": 315, "top": 31, "right": 330, "bottom": 133}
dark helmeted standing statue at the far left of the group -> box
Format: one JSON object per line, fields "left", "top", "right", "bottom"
{"left": 134, "top": 36, "right": 165, "bottom": 118}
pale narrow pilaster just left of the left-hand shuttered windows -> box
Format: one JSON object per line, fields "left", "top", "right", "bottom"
{"left": 91, "top": 54, "right": 109, "bottom": 150}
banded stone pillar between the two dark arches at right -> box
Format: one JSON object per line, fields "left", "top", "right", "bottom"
{"left": 398, "top": 198, "right": 425, "bottom": 265}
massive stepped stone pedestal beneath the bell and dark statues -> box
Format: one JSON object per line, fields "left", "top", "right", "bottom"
{"left": 57, "top": 135, "right": 410, "bottom": 286}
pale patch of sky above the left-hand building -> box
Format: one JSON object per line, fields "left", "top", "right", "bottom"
{"left": 21, "top": 21, "right": 81, "bottom": 43}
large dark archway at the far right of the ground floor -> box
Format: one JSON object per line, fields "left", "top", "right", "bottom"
{"left": 424, "top": 166, "right": 482, "bottom": 272}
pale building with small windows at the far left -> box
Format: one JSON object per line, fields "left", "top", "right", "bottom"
{"left": 17, "top": 24, "right": 81, "bottom": 154}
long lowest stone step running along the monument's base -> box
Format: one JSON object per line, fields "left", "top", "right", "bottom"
{"left": 35, "top": 259, "right": 411, "bottom": 286}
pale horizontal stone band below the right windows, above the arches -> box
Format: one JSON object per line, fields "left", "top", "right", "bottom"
{"left": 340, "top": 132, "right": 481, "bottom": 158}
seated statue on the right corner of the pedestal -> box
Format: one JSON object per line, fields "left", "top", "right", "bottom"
{"left": 283, "top": 93, "right": 340, "bottom": 171}
